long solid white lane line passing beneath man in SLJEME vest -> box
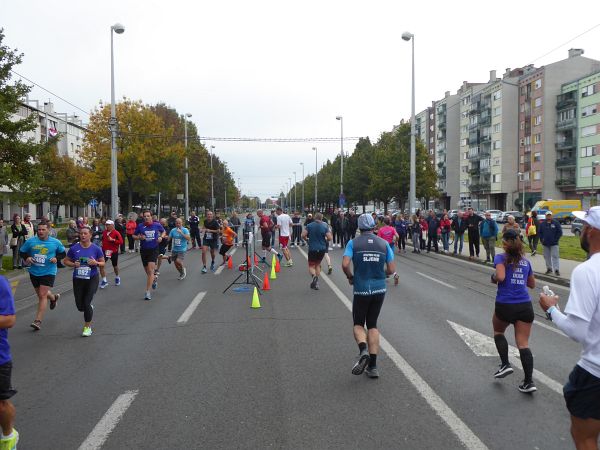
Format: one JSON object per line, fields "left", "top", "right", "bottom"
{"left": 298, "top": 248, "right": 487, "bottom": 450}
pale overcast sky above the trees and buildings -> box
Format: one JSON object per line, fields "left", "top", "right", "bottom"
{"left": 0, "top": 0, "right": 600, "bottom": 202}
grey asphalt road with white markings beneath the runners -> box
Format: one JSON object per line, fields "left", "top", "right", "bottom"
{"left": 10, "top": 241, "right": 580, "bottom": 449}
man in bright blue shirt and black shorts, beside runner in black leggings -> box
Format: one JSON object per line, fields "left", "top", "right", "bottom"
{"left": 19, "top": 222, "right": 66, "bottom": 331}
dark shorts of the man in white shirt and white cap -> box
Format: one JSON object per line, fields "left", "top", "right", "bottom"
{"left": 563, "top": 365, "right": 600, "bottom": 420}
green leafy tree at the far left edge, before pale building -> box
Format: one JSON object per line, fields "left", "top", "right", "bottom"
{"left": 0, "top": 29, "right": 49, "bottom": 192}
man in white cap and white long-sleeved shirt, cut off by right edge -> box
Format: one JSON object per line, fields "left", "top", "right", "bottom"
{"left": 540, "top": 206, "right": 600, "bottom": 449}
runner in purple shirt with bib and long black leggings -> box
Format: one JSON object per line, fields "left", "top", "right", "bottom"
{"left": 63, "top": 227, "right": 106, "bottom": 337}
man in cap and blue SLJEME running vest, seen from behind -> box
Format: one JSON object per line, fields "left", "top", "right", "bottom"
{"left": 342, "top": 214, "right": 398, "bottom": 378}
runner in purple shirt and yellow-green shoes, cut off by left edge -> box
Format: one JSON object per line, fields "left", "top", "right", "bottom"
{"left": 0, "top": 276, "right": 19, "bottom": 450}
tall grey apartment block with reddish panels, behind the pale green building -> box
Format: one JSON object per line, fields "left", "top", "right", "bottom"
{"left": 518, "top": 49, "right": 600, "bottom": 209}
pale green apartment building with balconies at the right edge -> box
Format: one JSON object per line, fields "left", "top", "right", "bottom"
{"left": 556, "top": 71, "right": 600, "bottom": 209}
